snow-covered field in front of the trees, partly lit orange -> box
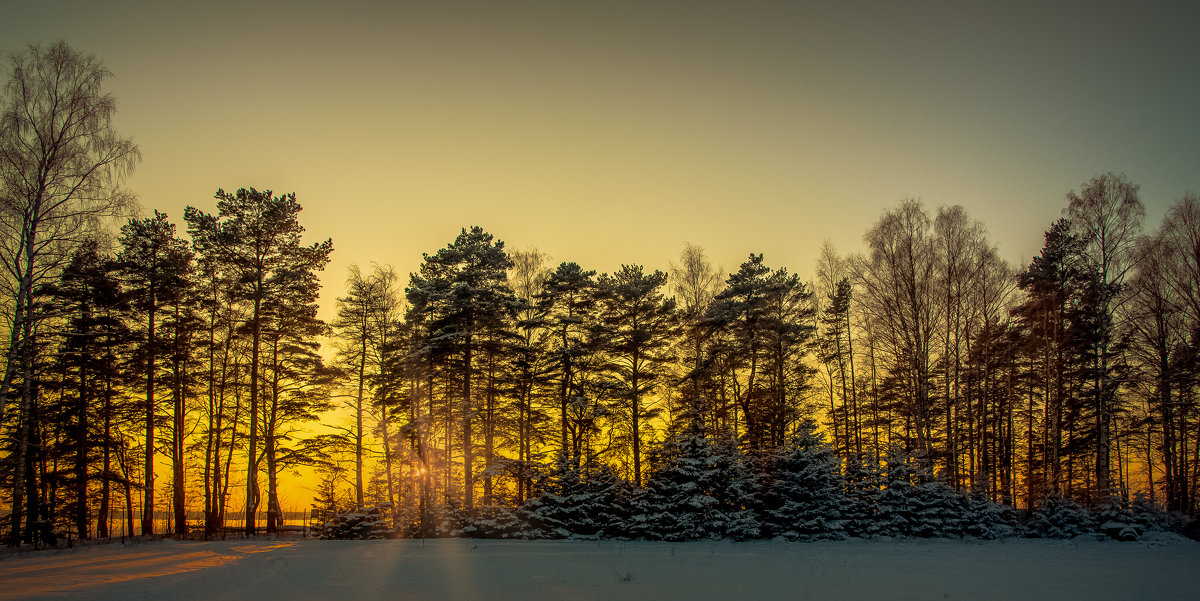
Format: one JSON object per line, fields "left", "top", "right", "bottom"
{"left": 0, "top": 535, "right": 1200, "bottom": 601}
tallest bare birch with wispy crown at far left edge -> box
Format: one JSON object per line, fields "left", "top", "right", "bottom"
{"left": 0, "top": 42, "right": 140, "bottom": 543}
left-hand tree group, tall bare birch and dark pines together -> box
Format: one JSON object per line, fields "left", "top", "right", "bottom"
{"left": 0, "top": 42, "right": 332, "bottom": 545}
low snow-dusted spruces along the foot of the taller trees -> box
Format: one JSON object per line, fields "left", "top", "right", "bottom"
{"left": 318, "top": 421, "right": 1178, "bottom": 542}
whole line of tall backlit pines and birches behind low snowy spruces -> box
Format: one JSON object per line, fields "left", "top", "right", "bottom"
{"left": 0, "top": 42, "right": 1200, "bottom": 543}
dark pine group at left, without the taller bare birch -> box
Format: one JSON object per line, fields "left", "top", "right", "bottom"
{"left": 5, "top": 181, "right": 332, "bottom": 542}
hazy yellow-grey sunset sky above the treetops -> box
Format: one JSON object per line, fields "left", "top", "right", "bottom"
{"left": 0, "top": 0, "right": 1200, "bottom": 317}
